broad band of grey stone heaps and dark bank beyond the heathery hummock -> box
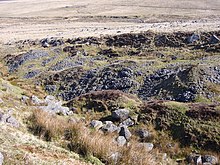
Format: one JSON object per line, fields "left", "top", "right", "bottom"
{"left": 4, "top": 31, "right": 220, "bottom": 102}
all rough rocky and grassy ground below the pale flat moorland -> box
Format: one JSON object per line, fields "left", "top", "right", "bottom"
{"left": 0, "top": 31, "right": 220, "bottom": 164}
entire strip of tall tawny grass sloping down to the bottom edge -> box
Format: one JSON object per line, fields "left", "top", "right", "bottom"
{"left": 31, "top": 110, "right": 156, "bottom": 165}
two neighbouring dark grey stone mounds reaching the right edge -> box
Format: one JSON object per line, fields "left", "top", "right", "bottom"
{"left": 43, "top": 64, "right": 220, "bottom": 102}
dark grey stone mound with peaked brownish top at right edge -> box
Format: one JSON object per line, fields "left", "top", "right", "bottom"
{"left": 138, "top": 65, "right": 220, "bottom": 102}
